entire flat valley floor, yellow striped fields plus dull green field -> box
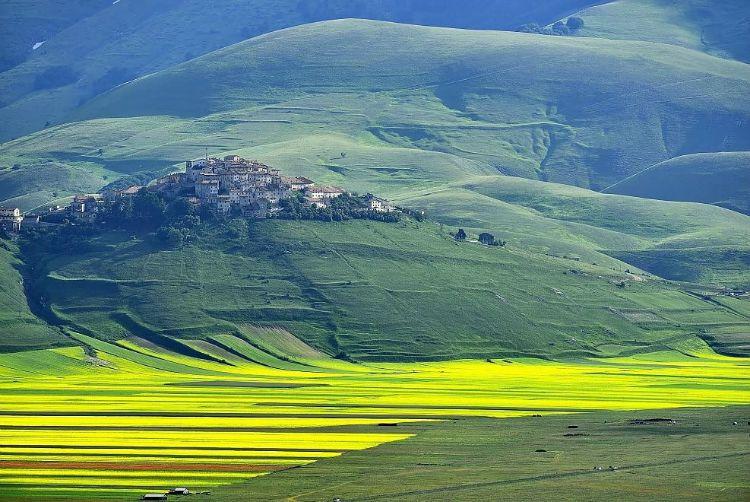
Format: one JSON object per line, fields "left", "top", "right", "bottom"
{"left": 0, "top": 335, "right": 750, "bottom": 500}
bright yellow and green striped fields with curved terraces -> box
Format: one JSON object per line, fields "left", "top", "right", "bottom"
{"left": 0, "top": 330, "right": 750, "bottom": 500}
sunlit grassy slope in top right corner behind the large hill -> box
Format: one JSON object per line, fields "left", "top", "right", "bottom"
{"left": 576, "top": 0, "right": 750, "bottom": 63}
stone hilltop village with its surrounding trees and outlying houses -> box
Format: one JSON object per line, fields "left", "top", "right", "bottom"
{"left": 0, "top": 155, "right": 398, "bottom": 232}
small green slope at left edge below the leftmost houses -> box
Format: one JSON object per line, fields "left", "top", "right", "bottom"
{"left": 0, "top": 238, "right": 70, "bottom": 352}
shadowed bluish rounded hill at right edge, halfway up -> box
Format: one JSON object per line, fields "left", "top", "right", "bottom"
{"left": 604, "top": 152, "right": 750, "bottom": 214}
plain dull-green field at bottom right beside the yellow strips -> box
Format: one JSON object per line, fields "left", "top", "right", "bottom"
{"left": 212, "top": 406, "right": 750, "bottom": 501}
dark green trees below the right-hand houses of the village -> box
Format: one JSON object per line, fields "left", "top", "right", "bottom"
{"left": 276, "top": 194, "right": 401, "bottom": 223}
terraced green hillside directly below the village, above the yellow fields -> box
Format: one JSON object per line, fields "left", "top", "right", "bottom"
{"left": 22, "top": 220, "right": 750, "bottom": 360}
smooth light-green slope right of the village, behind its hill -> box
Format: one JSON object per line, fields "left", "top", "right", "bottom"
{"left": 404, "top": 176, "right": 750, "bottom": 287}
